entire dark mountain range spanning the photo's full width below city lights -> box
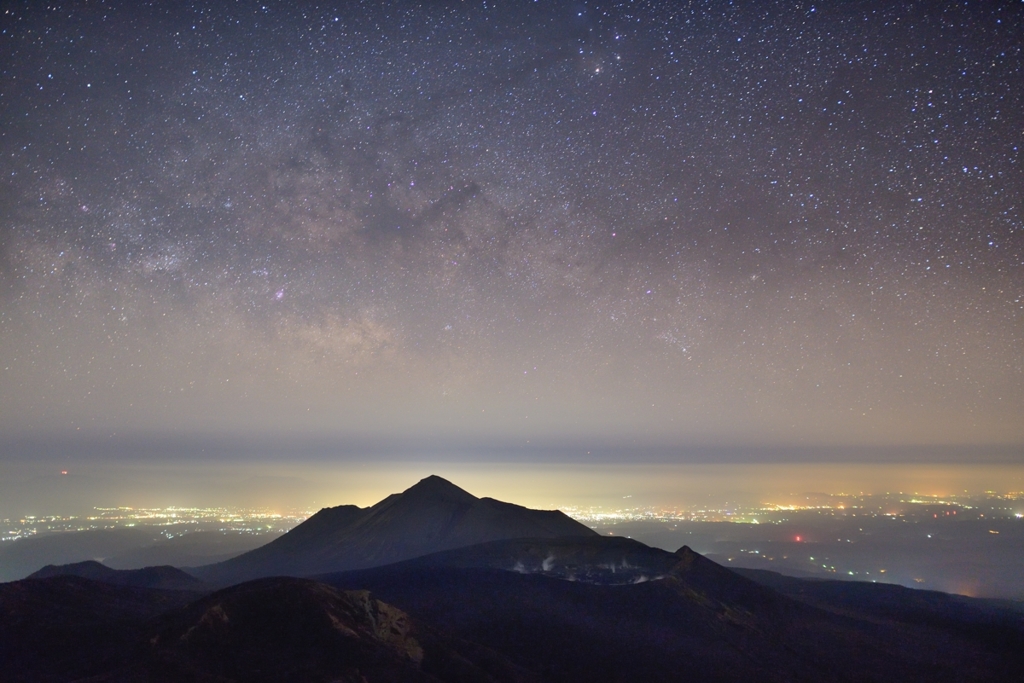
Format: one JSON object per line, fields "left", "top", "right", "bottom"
{"left": 0, "top": 477, "right": 1024, "bottom": 683}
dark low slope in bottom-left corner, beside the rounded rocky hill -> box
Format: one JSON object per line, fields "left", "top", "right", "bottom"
{"left": 0, "top": 575, "right": 198, "bottom": 683}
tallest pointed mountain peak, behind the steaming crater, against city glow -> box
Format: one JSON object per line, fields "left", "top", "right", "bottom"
{"left": 190, "top": 476, "right": 597, "bottom": 585}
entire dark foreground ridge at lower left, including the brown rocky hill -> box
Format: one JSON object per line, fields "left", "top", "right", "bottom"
{"left": 0, "top": 575, "right": 540, "bottom": 683}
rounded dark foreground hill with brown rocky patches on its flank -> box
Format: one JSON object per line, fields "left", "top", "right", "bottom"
{"left": 95, "top": 578, "right": 537, "bottom": 683}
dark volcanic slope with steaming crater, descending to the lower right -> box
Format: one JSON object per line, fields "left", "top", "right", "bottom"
{"left": 326, "top": 539, "right": 1017, "bottom": 682}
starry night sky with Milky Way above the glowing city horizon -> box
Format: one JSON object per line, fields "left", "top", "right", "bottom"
{"left": 0, "top": 0, "right": 1024, "bottom": 461}
